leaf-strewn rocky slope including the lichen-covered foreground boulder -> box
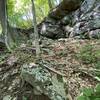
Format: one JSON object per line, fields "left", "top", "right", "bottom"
{"left": 0, "top": 38, "right": 100, "bottom": 100}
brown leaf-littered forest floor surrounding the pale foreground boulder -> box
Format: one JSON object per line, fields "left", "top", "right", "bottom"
{"left": 0, "top": 39, "right": 100, "bottom": 100}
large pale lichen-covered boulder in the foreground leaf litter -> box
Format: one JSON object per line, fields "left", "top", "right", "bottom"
{"left": 21, "top": 59, "right": 67, "bottom": 100}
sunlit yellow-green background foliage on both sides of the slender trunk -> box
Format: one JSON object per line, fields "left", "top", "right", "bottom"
{"left": 7, "top": 0, "right": 49, "bottom": 28}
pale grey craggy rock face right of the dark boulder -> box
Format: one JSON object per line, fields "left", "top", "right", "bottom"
{"left": 65, "top": 0, "right": 100, "bottom": 38}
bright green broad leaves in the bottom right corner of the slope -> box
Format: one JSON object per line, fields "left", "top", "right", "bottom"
{"left": 77, "top": 84, "right": 100, "bottom": 100}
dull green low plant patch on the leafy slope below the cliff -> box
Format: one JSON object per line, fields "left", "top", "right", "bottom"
{"left": 77, "top": 44, "right": 100, "bottom": 64}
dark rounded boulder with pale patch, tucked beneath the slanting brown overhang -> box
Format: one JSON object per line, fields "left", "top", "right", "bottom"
{"left": 39, "top": 17, "right": 66, "bottom": 39}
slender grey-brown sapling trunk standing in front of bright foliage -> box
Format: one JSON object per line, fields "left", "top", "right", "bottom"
{"left": 31, "top": 0, "right": 40, "bottom": 58}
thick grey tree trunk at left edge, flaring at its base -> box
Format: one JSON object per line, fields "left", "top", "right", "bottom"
{"left": 0, "top": 0, "right": 16, "bottom": 51}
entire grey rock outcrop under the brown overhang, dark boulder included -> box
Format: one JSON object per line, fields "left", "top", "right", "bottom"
{"left": 39, "top": 0, "right": 100, "bottom": 39}
